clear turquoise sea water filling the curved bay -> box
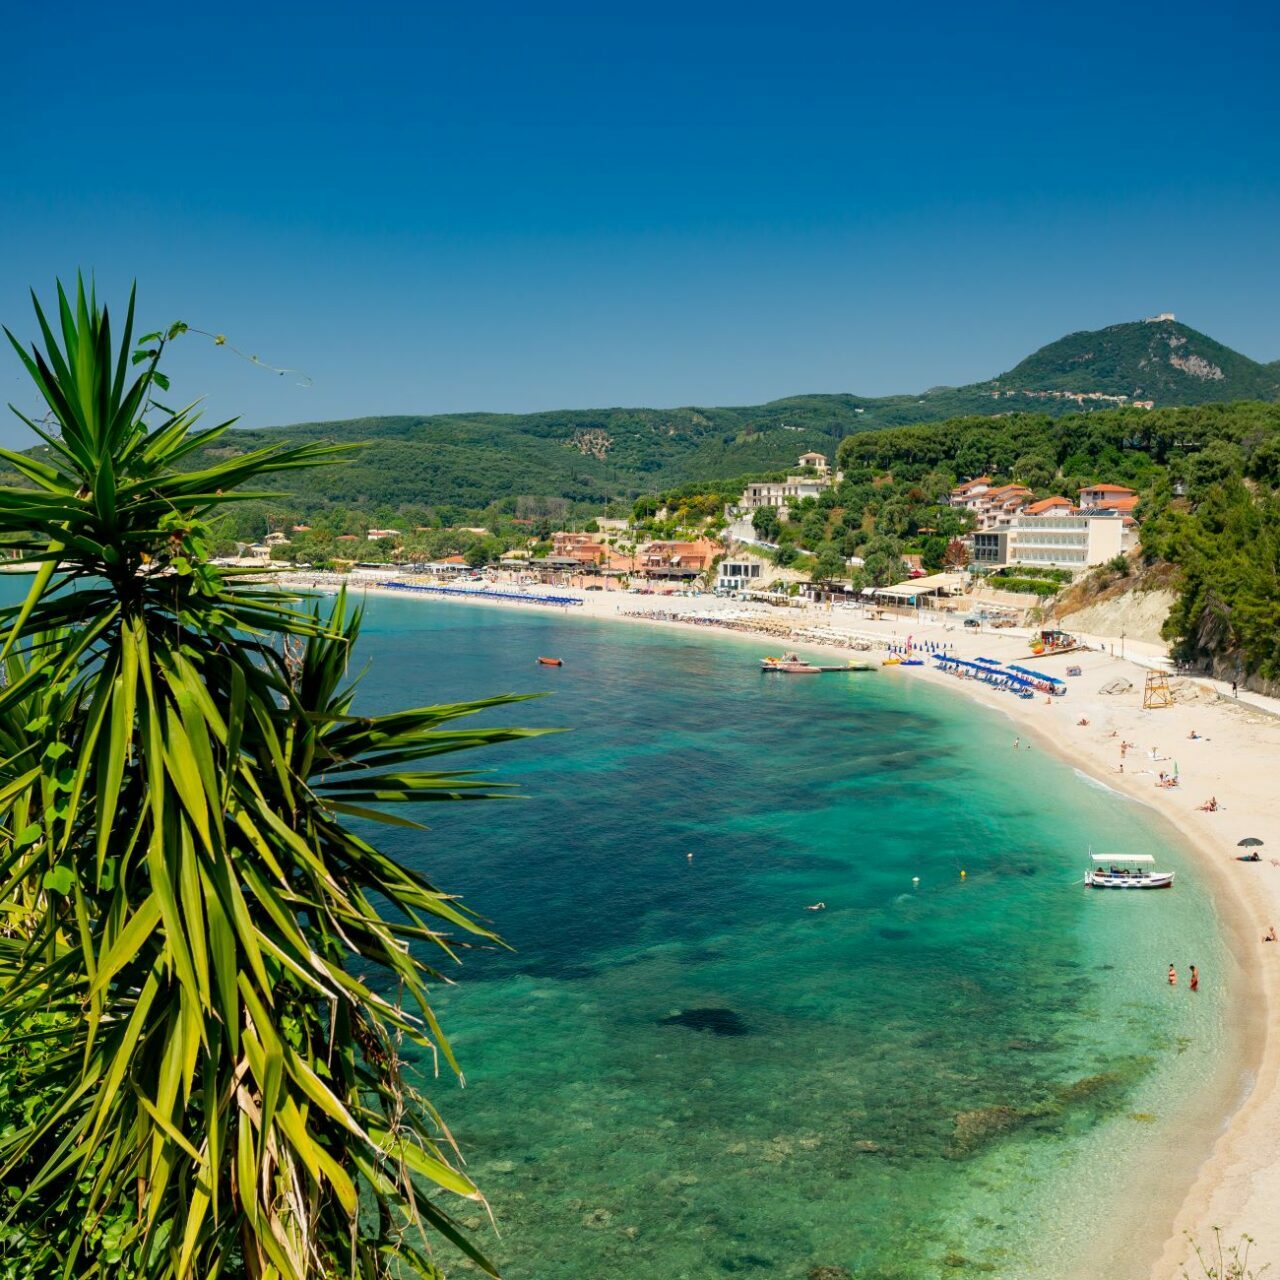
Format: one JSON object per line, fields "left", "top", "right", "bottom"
{"left": 343, "top": 598, "right": 1233, "bottom": 1280}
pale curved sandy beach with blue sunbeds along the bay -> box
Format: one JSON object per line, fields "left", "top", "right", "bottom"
{"left": 287, "top": 576, "right": 1280, "bottom": 1280}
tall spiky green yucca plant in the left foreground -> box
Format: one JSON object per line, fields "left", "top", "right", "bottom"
{"left": 0, "top": 282, "right": 532, "bottom": 1280}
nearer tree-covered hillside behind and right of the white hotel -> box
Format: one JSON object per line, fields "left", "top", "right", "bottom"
{"left": 840, "top": 402, "right": 1280, "bottom": 692}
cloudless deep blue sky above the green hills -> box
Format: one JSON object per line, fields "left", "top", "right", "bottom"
{"left": 0, "top": 0, "right": 1280, "bottom": 440}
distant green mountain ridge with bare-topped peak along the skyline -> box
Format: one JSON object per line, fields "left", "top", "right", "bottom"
{"left": 218, "top": 316, "right": 1280, "bottom": 509}
